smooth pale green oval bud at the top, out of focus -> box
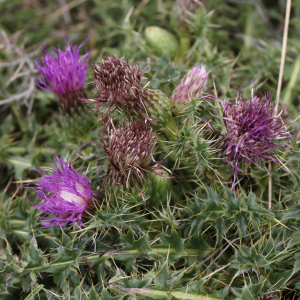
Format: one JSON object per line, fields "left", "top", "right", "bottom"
{"left": 145, "top": 26, "right": 179, "bottom": 59}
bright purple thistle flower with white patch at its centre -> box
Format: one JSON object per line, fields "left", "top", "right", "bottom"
{"left": 23, "top": 149, "right": 99, "bottom": 228}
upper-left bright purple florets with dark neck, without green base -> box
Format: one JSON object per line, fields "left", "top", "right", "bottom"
{"left": 35, "top": 37, "right": 90, "bottom": 112}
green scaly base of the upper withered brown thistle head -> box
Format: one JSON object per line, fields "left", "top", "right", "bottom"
{"left": 145, "top": 89, "right": 173, "bottom": 130}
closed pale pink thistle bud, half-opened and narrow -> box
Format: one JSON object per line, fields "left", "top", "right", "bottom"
{"left": 172, "top": 65, "right": 208, "bottom": 111}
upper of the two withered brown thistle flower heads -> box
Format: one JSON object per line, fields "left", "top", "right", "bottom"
{"left": 85, "top": 56, "right": 154, "bottom": 122}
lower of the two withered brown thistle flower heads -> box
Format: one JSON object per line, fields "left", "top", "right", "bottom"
{"left": 103, "top": 121, "right": 168, "bottom": 203}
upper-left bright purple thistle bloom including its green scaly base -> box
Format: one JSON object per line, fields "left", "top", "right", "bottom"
{"left": 35, "top": 38, "right": 94, "bottom": 140}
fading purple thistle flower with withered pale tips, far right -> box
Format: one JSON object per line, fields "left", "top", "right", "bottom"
{"left": 212, "top": 87, "right": 294, "bottom": 191}
